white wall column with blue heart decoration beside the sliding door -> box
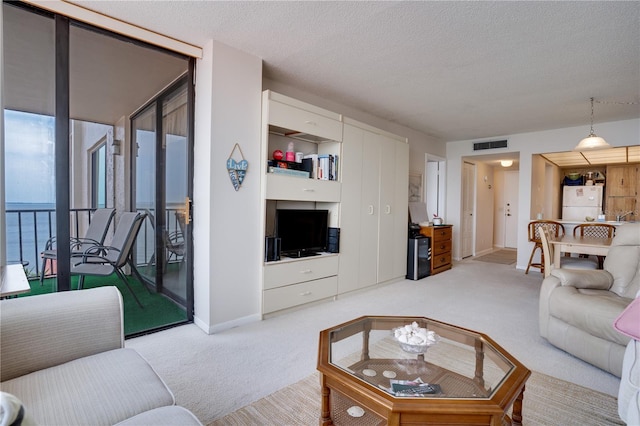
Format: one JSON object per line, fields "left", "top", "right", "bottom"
{"left": 193, "top": 41, "right": 262, "bottom": 333}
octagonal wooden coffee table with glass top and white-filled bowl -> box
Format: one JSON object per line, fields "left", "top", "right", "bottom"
{"left": 318, "top": 316, "right": 531, "bottom": 426}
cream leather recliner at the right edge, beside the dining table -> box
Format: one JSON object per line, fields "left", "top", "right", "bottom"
{"left": 538, "top": 223, "right": 640, "bottom": 377}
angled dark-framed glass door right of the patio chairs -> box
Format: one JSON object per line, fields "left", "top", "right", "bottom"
{"left": 131, "top": 76, "right": 193, "bottom": 320}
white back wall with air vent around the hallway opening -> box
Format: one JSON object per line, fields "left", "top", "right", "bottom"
{"left": 446, "top": 119, "right": 640, "bottom": 269}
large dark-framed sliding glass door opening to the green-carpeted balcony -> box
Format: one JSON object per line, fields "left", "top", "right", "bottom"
{"left": 1, "top": 2, "right": 195, "bottom": 335}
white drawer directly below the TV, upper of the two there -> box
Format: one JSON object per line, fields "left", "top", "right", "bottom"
{"left": 264, "top": 255, "right": 338, "bottom": 290}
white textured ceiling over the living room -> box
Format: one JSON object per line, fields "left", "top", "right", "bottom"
{"left": 73, "top": 0, "right": 640, "bottom": 141}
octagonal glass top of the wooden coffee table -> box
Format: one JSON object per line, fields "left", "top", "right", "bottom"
{"left": 328, "top": 317, "right": 515, "bottom": 399}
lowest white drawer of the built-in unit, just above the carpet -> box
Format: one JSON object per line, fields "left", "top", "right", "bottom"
{"left": 262, "top": 276, "right": 338, "bottom": 314}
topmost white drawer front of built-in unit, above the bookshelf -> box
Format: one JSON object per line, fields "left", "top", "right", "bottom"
{"left": 269, "top": 100, "right": 342, "bottom": 142}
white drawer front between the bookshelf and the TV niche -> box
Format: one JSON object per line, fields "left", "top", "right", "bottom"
{"left": 267, "top": 173, "right": 341, "bottom": 203}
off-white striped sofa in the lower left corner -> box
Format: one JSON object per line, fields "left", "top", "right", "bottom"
{"left": 0, "top": 287, "right": 201, "bottom": 426}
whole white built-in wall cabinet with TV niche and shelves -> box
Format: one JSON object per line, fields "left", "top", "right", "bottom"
{"left": 261, "top": 90, "right": 409, "bottom": 315}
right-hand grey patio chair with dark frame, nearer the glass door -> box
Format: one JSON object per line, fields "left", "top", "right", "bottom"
{"left": 71, "top": 212, "right": 146, "bottom": 308}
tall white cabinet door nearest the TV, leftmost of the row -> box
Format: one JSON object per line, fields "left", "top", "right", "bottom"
{"left": 338, "top": 124, "right": 364, "bottom": 293}
